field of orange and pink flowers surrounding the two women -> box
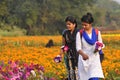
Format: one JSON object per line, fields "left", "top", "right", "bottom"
{"left": 0, "top": 34, "right": 120, "bottom": 80}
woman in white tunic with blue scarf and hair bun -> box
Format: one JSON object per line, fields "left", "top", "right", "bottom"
{"left": 76, "top": 13, "right": 104, "bottom": 80}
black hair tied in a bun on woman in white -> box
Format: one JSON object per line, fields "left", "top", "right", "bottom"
{"left": 81, "top": 13, "right": 94, "bottom": 24}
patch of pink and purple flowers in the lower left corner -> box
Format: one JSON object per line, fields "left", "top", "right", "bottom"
{"left": 0, "top": 61, "right": 49, "bottom": 80}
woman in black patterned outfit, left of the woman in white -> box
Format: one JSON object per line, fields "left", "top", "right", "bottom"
{"left": 61, "top": 16, "right": 78, "bottom": 80}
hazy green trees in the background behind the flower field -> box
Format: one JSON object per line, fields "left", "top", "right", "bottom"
{"left": 0, "top": 0, "right": 120, "bottom": 35}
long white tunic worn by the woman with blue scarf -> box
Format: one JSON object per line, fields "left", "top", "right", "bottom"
{"left": 76, "top": 31, "right": 104, "bottom": 80}
